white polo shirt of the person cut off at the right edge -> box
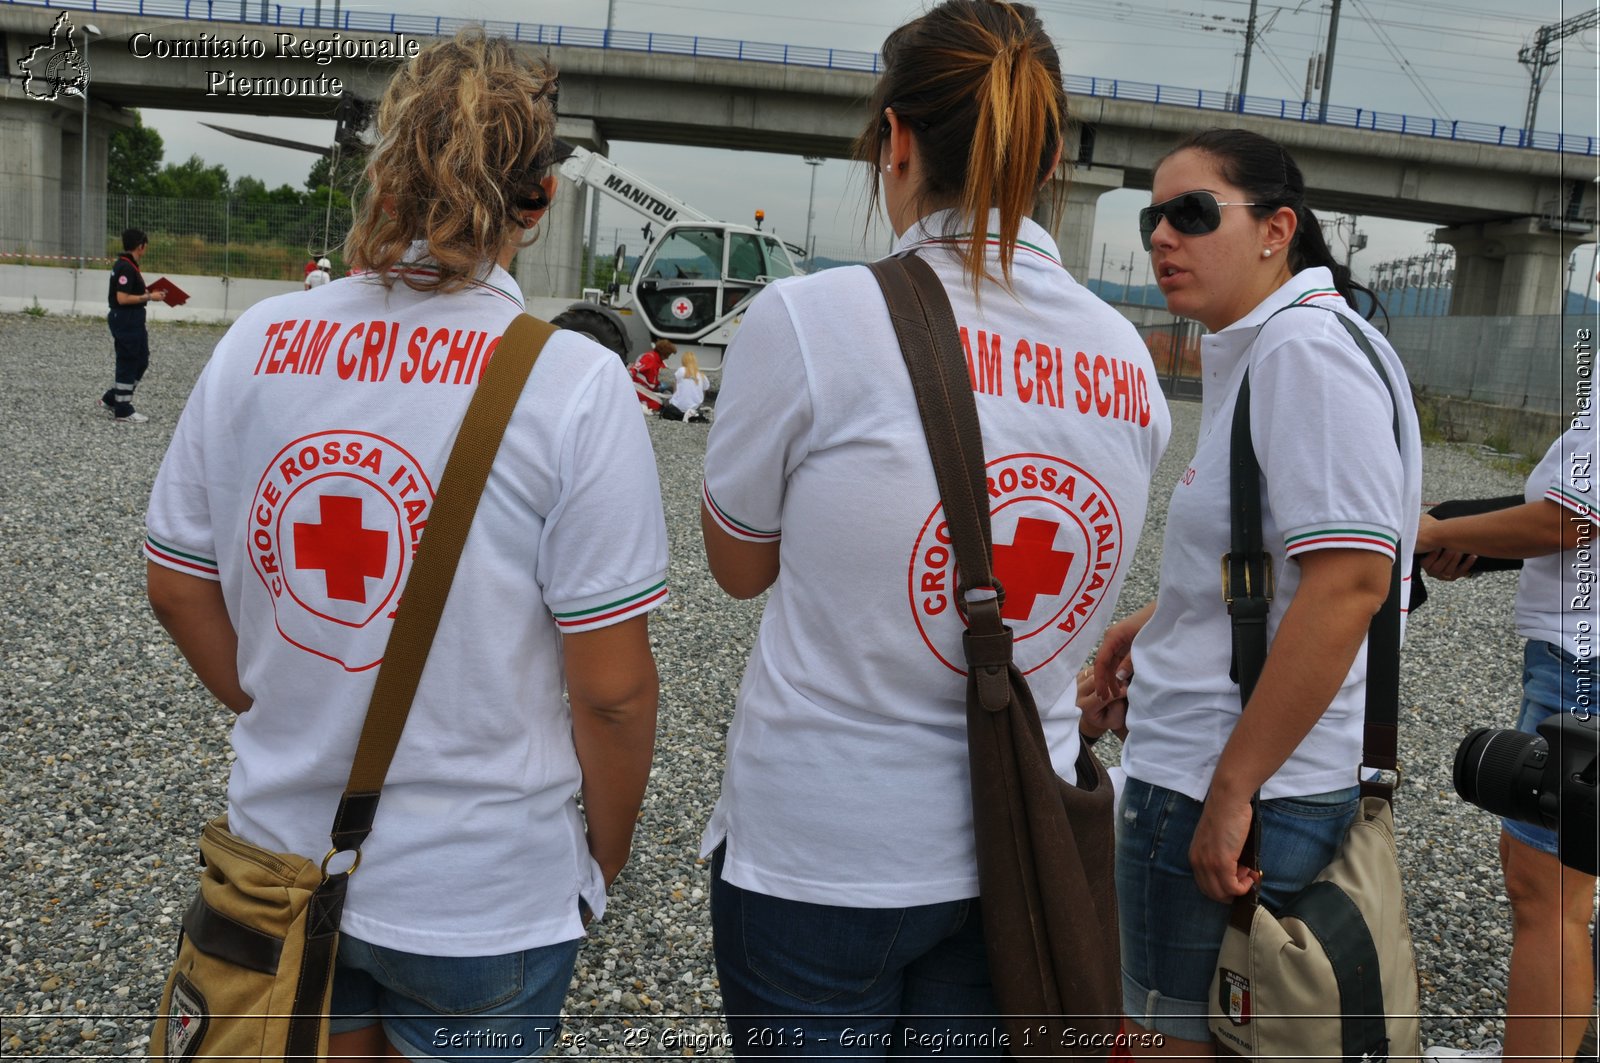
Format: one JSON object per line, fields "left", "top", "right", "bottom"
{"left": 1517, "top": 416, "right": 1600, "bottom": 660}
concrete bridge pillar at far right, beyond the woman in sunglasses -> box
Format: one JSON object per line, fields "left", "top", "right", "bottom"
{"left": 1434, "top": 218, "right": 1581, "bottom": 315}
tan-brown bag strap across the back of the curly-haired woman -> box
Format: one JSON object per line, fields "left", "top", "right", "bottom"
{"left": 333, "top": 314, "right": 557, "bottom": 850}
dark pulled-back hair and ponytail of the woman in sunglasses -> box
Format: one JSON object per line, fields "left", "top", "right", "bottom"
{"left": 1155, "top": 130, "right": 1389, "bottom": 320}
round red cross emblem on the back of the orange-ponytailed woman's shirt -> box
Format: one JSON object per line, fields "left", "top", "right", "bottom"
{"left": 907, "top": 455, "right": 1122, "bottom": 674}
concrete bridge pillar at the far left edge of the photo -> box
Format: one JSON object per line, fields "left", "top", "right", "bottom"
{"left": 0, "top": 93, "right": 112, "bottom": 259}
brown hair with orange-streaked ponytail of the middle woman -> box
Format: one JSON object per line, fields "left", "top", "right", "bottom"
{"left": 856, "top": 0, "right": 1067, "bottom": 290}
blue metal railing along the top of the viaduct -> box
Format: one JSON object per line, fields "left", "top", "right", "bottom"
{"left": 0, "top": 0, "right": 1600, "bottom": 155}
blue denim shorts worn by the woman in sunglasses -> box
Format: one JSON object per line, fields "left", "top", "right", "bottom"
{"left": 1117, "top": 778, "right": 1358, "bottom": 1042}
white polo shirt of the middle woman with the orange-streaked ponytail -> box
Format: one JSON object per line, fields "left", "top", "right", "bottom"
{"left": 702, "top": 215, "right": 1171, "bottom": 908}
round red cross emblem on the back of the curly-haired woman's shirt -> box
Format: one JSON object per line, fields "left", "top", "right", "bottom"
{"left": 246, "top": 431, "right": 434, "bottom": 671}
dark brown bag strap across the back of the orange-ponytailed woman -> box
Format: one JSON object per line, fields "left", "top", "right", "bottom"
{"left": 867, "top": 255, "right": 1011, "bottom": 712}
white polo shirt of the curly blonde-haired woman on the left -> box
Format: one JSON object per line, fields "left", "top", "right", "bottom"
{"left": 144, "top": 248, "right": 667, "bottom": 956}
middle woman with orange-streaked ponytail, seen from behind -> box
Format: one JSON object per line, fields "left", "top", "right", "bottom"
{"left": 701, "top": 0, "right": 1170, "bottom": 1058}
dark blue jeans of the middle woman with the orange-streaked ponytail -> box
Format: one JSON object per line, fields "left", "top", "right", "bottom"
{"left": 710, "top": 847, "right": 1003, "bottom": 1060}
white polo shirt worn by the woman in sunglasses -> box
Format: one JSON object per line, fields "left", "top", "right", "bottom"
{"left": 1122, "top": 267, "right": 1422, "bottom": 800}
